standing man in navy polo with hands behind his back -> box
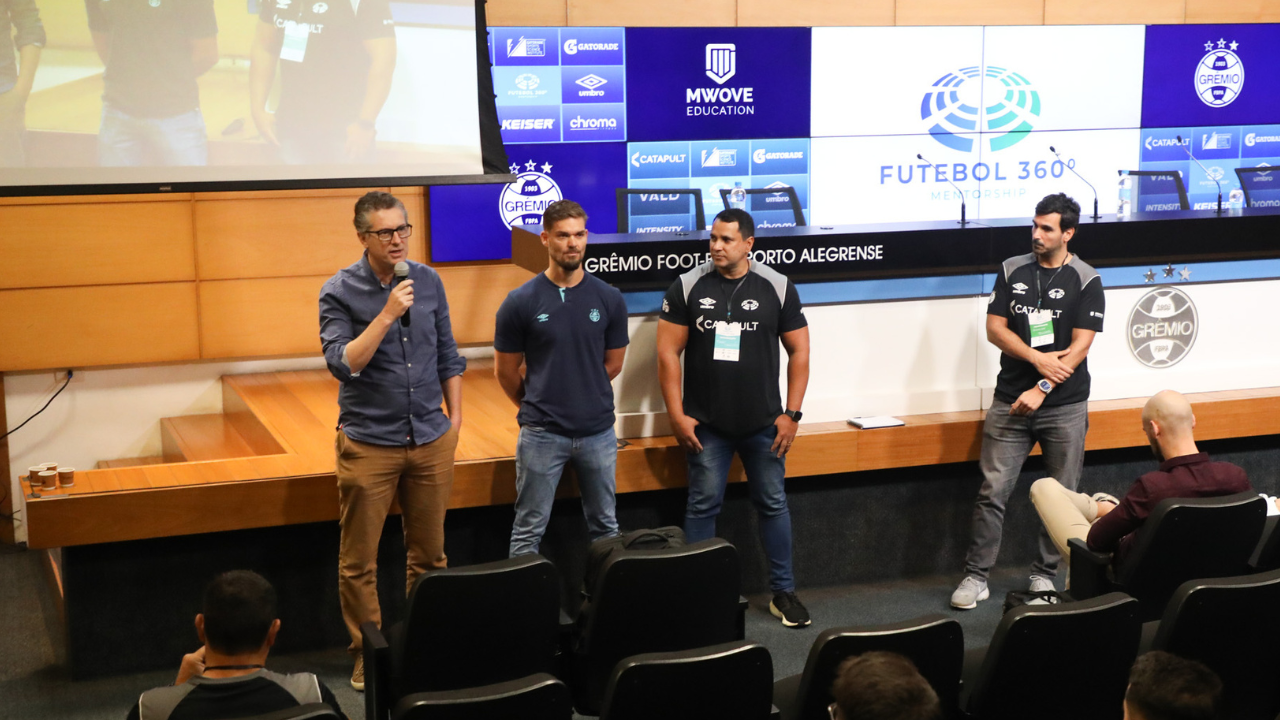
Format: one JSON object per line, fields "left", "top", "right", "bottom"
{"left": 493, "top": 200, "right": 628, "bottom": 557}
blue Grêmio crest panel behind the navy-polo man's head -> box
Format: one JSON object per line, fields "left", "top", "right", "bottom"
{"left": 429, "top": 142, "right": 627, "bottom": 263}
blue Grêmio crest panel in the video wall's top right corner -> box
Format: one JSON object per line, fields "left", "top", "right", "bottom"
{"left": 1142, "top": 24, "right": 1280, "bottom": 127}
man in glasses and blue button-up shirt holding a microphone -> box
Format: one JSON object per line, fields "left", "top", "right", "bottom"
{"left": 320, "top": 192, "right": 466, "bottom": 691}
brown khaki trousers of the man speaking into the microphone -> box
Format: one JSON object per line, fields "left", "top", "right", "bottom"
{"left": 335, "top": 428, "right": 458, "bottom": 653}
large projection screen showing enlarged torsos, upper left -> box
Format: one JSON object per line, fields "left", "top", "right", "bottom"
{"left": 0, "top": 0, "right": 506, "bottom": 195}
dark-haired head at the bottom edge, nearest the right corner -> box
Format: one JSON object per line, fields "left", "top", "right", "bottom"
{"left": 1124, "top": 650, "right": 1222, "bottom": 720}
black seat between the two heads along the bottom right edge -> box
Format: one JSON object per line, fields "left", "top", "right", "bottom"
{"left": 964, "top": 592, "right": 1142, "bottom": 720}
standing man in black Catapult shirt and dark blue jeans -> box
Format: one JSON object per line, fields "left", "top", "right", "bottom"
{"left": 658, "top": 208, "right": 809, "bottom": 628}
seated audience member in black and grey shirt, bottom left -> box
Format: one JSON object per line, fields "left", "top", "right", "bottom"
{"left": 129, "top": 570, "right": 346, "bottom": 720}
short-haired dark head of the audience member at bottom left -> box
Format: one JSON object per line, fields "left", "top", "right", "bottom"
{"left": 201, "top": 570, "right": 276, "bottom": 655}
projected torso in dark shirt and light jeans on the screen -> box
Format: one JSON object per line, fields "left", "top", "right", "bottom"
{"left": 84, "top": 0, "right": 218, "bottom": 167}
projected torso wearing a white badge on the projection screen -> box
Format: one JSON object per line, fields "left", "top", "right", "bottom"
{"left": 250, "top": 0, "right": 396, "bottom": 164}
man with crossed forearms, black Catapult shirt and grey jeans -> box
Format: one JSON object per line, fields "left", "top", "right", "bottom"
{"left": 951, "top": 193, "right": 1106, "bottom": 610}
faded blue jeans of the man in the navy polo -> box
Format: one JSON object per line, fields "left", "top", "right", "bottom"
{"left": 511, "top": 427, "right": 618, "bottom": 557}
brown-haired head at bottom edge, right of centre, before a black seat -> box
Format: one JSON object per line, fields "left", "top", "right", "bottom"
{"left": 831, "top": 652, "right": 942, "bottom": 720}
